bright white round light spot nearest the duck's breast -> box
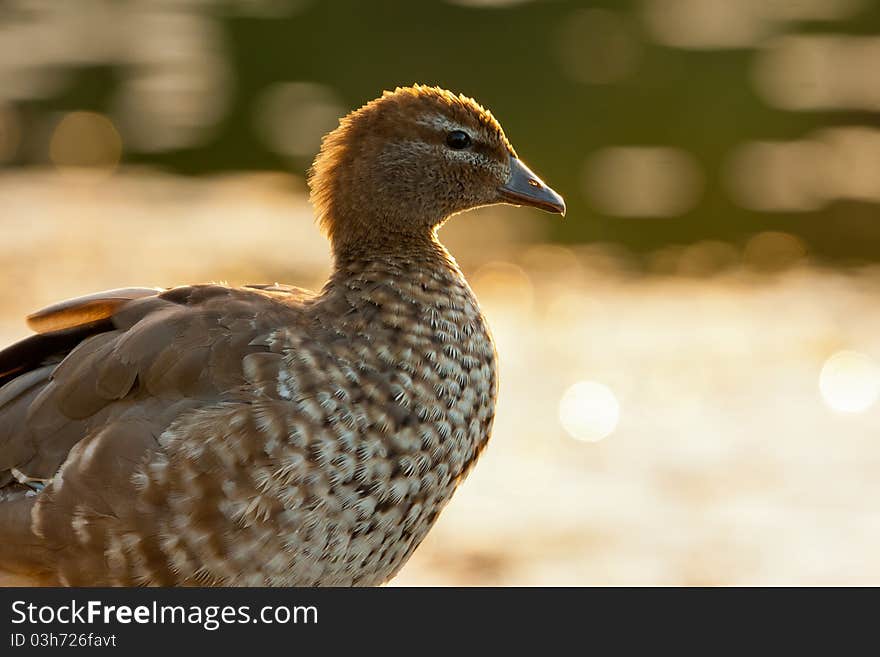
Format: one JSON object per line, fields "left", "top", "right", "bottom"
{"left": 559, "top": 381, "right": 620, "bottom": 442}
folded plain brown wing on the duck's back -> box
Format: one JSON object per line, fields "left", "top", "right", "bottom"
{"left": 0, "top": 285, "right": 308, "bottom": 482}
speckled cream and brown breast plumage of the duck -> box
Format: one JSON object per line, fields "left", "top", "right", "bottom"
{"left": 94, "top": 247, "right": 496, "bottom": 586}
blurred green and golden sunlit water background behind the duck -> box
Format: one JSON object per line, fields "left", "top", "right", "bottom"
{"left": 0, "top": 0, "right": 880, "bottom": 585}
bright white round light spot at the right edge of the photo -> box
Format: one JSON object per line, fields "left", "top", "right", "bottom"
{"left": 819, "top": 351, "right": 880, "bottom": 413}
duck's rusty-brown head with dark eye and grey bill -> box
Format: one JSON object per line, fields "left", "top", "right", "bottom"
{"left": 309, "top": 85, "right": 565, "bottom": 250}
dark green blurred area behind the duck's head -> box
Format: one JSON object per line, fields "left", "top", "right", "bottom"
{"left": 12, "top": 0, "right": 880, "bottom": 264}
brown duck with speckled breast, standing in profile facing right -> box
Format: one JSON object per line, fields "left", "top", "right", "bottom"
{"left": 0, "top": 85, "right": 565, "bottom": 587}
